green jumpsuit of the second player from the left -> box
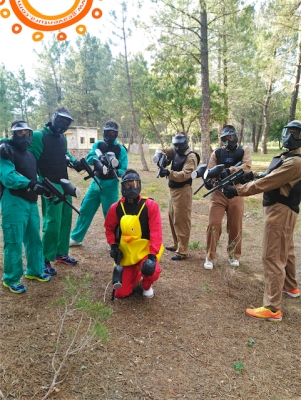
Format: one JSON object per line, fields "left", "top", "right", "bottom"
{"left": 28, "top": 125, "right": 76, "bottom": 261}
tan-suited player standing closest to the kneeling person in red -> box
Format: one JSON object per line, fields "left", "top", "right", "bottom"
{"left": 156, "top": 132, "right": 200, "bottom": 261}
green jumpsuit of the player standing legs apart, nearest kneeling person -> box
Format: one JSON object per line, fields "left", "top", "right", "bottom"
{"left": 71, "top": 140, "right": 128, "bottom": 242}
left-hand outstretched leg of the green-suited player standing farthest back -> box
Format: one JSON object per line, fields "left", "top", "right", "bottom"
{"left": 71, "top": 182, "right": 100, "bottom": 242}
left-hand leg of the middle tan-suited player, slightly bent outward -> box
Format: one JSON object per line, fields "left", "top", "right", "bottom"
{"left": 207, "top": 190, "right": 227, "bottom": 261}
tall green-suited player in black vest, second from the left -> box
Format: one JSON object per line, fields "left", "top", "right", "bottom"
{"left": 28, "top": 107, "right": 83, "bottom": 275}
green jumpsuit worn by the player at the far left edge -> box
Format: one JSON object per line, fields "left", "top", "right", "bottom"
{"left": 0, "top": 152, "right": 44, "bottom": 286}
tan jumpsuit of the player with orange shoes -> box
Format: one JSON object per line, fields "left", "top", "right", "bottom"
{"left": 236, "top": 149, "right": 301, "bottom": 311}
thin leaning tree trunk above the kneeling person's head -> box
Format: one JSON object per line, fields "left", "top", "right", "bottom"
{"left": 122, "top": 11, "right": 149, "bottom": 171}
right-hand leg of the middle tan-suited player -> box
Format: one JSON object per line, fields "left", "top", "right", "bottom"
{"left": 226, "top": 196, "right": 244, "bottom": 260}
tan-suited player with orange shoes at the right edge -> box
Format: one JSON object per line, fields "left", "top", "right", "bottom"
{"left": 225, "top": 121, "right": 301, "bottom": 321}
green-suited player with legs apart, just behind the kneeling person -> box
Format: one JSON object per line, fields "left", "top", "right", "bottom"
{"left": 70, "top": 121, "right": 128, "bottom": 246}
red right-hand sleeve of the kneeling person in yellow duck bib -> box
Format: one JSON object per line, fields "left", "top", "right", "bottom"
{"left": 145, "top": 199, "right": 162, "bottom": 255}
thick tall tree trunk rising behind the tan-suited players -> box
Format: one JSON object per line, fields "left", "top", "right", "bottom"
{"left": 199, "top": 0, "right": 211, "bottom": 164}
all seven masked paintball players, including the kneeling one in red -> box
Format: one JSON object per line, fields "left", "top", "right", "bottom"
{"left": 0, "top": 111, "right": 301, "bottom": 321}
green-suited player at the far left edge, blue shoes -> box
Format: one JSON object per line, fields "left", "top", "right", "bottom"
{"left": 0, "top": 120, "right": 51, "bottom": 294}
